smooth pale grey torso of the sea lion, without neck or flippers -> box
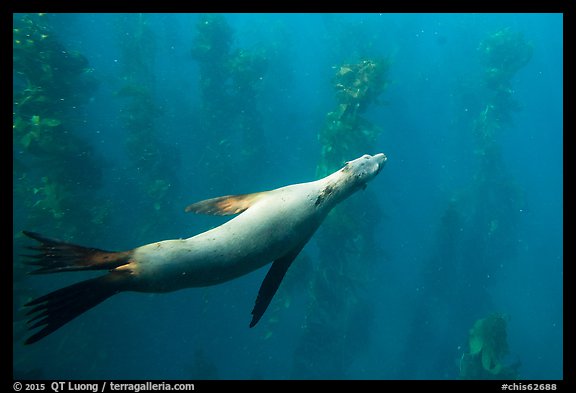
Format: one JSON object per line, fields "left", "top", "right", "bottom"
{"left": 134, "top": 183, "right": 325, "bottom": 292}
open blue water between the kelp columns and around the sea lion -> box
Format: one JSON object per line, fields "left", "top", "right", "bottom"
{"left": 13, "top": 14, "right": 563, "bottom": 379}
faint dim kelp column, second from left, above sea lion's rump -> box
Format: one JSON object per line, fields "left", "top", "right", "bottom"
{"left": 115, "top": 14, "right": 178, "bottom": 227}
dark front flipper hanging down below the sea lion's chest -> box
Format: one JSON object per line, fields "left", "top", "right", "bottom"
{"left": 250, "top": 242, "right": 306, "bottom": 327}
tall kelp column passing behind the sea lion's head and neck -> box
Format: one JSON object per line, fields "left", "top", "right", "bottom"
{"left": 293, "top": 59, "right": 390, "bottom": 378}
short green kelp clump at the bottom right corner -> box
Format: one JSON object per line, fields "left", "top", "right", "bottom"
{"left": 460, "top": 313, "right": 520, "bottom": 379}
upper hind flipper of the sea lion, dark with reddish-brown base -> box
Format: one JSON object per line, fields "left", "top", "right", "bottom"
{"left": 23, "top": 231, "right": 132, "bottom": 274}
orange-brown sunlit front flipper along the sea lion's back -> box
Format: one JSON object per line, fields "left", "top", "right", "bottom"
{"left": 184, "top": 191, "right": 268, "bottom": 216}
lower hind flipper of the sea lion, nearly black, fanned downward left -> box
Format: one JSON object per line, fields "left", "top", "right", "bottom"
{"left": 25, "top": 272, "right": 129, "bottom": 344}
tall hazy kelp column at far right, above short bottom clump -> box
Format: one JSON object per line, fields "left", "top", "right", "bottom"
{"left": 461, "top": 28, "right": 533, "bottom": 260}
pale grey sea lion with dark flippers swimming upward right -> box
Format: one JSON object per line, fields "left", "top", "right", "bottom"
{"left": 24, "top": 153, "right": 386, "bottom": 344}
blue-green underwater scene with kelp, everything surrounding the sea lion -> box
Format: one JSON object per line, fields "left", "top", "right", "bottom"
{"left": 13, "top": 14, "right": 563, "bottom": 379}
